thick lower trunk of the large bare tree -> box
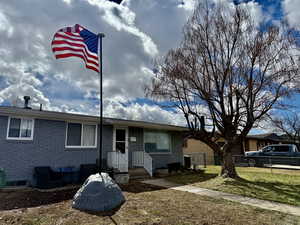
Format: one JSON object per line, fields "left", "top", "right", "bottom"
{"left": 221, "top": 146, "right": 238, "bottom": 178}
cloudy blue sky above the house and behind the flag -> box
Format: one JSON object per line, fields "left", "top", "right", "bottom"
{"left": 0, "top": 0, "right": 300, "bottom": 133}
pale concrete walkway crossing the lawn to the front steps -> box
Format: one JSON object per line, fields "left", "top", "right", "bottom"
{"left": 142, "top": 179, "right": 300, "bottom": 216}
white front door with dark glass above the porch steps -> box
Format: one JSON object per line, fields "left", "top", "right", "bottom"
{"left": 113, "top": 127, "right": 128, "bottom": 172}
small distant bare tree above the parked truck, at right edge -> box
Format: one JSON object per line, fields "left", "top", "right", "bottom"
{"left": 272, "top": 113, "right": 300, "bottom": 147}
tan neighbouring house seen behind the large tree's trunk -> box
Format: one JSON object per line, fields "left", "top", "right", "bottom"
{"left": 183, "top": 133, "right": 292, "bottom": 165}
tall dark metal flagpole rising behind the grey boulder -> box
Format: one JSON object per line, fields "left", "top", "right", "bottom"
{"left": 98, "top": 33, "right": 105, "bottom": 173}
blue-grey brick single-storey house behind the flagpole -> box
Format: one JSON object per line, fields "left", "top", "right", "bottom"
{"left": 0, "top": 106, "right": 186, "bottom": 183}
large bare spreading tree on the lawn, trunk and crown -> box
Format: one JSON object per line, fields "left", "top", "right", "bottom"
{"left": 147, "top": 2, "right": 299, "bottom": 178}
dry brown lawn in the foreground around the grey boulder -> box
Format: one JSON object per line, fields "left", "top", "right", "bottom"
{"left": 0, "top": 183, "right": 300, "bottom": 225}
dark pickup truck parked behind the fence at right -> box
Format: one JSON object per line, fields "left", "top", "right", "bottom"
{"left": 245, "top": 144, "right": 300, "bottom": 166}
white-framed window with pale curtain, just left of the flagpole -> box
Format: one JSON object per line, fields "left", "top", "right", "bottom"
{"left": 66, "top": 123, "right": 97, "bottom": 148}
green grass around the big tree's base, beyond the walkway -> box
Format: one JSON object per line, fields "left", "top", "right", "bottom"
{"left": 167, "top": 166, "right": 300, "bottom": 206}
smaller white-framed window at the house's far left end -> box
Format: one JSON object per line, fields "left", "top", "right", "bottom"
{"left": 7, "top": 117, "right": 34, "bottom": 140}
